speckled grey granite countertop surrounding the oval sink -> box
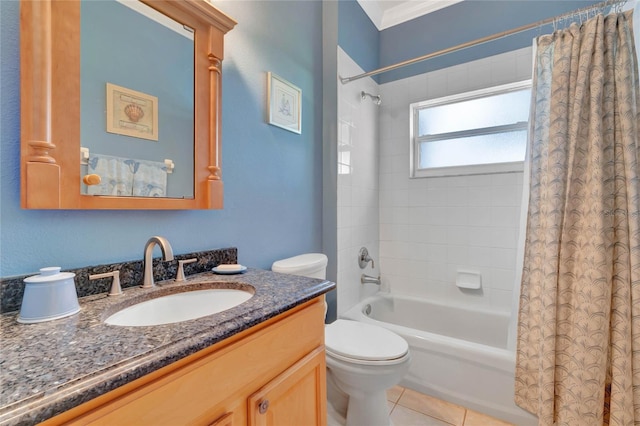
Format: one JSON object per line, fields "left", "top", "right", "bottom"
{"left": 0, "top": 269, "right": 335, "bottom": 425}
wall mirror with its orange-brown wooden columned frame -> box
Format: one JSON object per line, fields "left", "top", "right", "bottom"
{"left": 20, "top": 0, "right": 236, "bottom": 209}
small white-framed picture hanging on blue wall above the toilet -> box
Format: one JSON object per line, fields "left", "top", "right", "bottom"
{"left": 267, "top": 72, "right": 302, "bottom": 134}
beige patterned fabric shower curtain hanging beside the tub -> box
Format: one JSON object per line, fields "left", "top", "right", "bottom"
{"left": 515, "top": 11, "right": 640, "bottom": 426}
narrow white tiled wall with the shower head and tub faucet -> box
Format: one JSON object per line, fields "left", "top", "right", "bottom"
{"left": 337, "top": 49, "right": 380, "bottom": 315}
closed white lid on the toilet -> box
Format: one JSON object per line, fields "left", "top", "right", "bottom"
{"left": 324, "top": 319, "right": 409, "bottom": 361}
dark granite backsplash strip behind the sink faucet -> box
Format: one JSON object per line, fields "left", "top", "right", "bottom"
{"left": 0, "top": 247, "right": 238, "bottom": 313}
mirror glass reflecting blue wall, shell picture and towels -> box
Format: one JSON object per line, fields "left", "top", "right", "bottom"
{"left": 80, "top": 0, "right": 194, "bottom": 199}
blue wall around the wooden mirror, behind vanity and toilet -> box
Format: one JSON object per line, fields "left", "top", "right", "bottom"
{"left": 0, "top": 0, "right": 322, "bottom": 277}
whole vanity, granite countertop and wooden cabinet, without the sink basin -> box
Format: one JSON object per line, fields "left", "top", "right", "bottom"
{"left": 0, "top": 269, "right": 335, "bottom": 425}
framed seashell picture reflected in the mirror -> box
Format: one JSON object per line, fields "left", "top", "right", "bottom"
{"left": 106, "top": 83, "right": 158, "bottom": 141}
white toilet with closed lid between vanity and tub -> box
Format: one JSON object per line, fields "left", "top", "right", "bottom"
{"left": 271, "top": 253, "right": 411, "bottom": 426}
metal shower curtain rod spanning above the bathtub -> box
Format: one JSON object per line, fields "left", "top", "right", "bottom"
{"left": 339, "top": 0, "right": 627, "bottom": 84}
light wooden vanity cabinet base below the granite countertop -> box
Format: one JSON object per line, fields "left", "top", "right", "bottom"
{"left": 43, "top": 299, "right": 326, "bottom": 425}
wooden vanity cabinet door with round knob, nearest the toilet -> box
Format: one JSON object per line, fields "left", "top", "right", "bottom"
{"left": 248, "top": 347, "right": 327, "bottom": 426}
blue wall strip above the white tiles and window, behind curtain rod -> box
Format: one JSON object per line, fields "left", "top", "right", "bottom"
{"left": 380, "top": 0, "right": 599, "bottom": 83}
